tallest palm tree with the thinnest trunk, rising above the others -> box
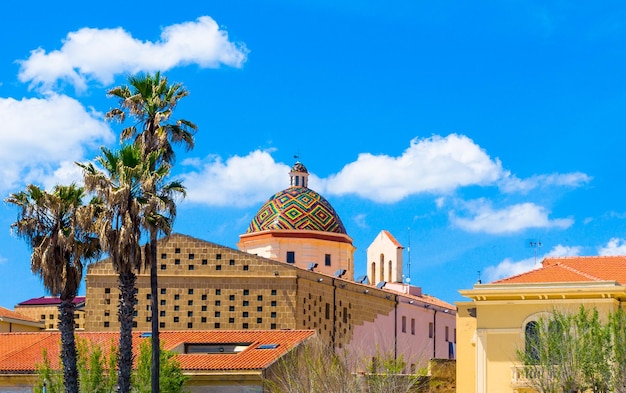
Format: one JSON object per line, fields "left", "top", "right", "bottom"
{"left": 106, "top": 72, "right": 197, "bottom": 393}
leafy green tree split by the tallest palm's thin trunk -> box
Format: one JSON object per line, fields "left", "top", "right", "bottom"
{"left": 133, "top": 341, "right": 189, "bottom": 393}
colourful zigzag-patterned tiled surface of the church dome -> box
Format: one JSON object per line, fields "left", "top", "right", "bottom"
{"left": 246, "top": 187, "right": 346, "bottom": 234}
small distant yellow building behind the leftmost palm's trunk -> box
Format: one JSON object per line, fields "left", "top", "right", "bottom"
{"left": 15, "top": 296, "right": 85, "bottom": 330}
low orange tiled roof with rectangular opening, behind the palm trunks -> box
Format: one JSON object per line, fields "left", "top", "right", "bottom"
{"left": 0, "top": 330, "right": 315, "bottom": 373}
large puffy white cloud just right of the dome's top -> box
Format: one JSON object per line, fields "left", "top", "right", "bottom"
{"left": 326, "top": 134, "right": 504, "bottom": 203}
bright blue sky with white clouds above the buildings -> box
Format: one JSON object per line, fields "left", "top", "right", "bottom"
{"left": 0, "top": 0, "right": 626, "bottom": 308}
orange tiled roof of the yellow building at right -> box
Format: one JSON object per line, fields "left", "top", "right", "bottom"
{"left": 493, "top": 255, "right": 626, "bottom": 285}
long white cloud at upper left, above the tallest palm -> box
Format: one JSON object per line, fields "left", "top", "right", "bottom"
{"left": 19, "top": 16, "right": 248, "bottom": 91}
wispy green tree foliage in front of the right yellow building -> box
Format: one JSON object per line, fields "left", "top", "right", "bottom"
{"left": 517, "top": 306, "right": 626, "bottom": 393}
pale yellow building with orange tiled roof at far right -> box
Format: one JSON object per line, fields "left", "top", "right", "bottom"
{"left": 456, "top": 256, "right": 626, "bottom": 393}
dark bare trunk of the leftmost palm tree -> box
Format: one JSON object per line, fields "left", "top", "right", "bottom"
{"left": 59, "top": 298, "right": 78, "bottom": 393}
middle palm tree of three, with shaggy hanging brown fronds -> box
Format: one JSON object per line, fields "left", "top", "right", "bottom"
{"left": 79, "top": 145, "right": 184, "bottom": 392}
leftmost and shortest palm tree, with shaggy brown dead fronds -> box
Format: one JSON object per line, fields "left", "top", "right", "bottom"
{"left": 5, "top": 184, "right": 100, "bottom": 393}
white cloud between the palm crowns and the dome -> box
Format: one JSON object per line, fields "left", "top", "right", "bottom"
{"left": 183, "top": 150, "right": 288, "bottom": 207}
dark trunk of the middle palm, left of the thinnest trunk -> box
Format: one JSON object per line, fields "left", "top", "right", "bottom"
{"left": 117, "top": 271, "right": 137, "bottom": 393}
